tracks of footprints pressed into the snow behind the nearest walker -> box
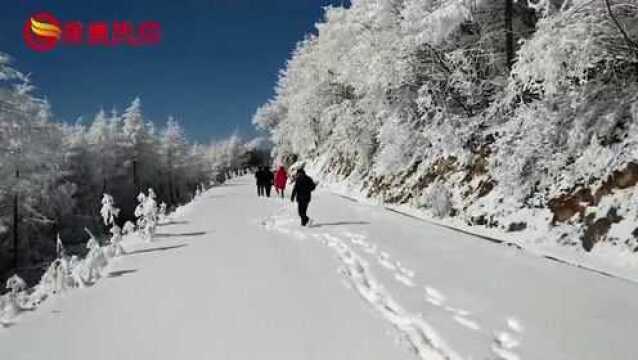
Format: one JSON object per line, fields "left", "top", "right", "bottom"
{"left": 262, "top": 216, "right": 523, "bottom": 360}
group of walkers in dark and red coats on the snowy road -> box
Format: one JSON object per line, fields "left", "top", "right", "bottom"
{"left": 255, "top": 166, "right": 317, "bottom": 226}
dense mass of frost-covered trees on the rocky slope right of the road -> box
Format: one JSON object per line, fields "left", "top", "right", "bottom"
{"left": 253, "top": 0, "right": 638, "bottom": 253}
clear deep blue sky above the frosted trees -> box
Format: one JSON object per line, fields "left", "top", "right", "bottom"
{"left": 0, "top": 0, "right": 347, "bottom": 142}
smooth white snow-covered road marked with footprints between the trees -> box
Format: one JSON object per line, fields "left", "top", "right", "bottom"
{"left": 0, "top": 178, "right": 638, "bottom": 360}
